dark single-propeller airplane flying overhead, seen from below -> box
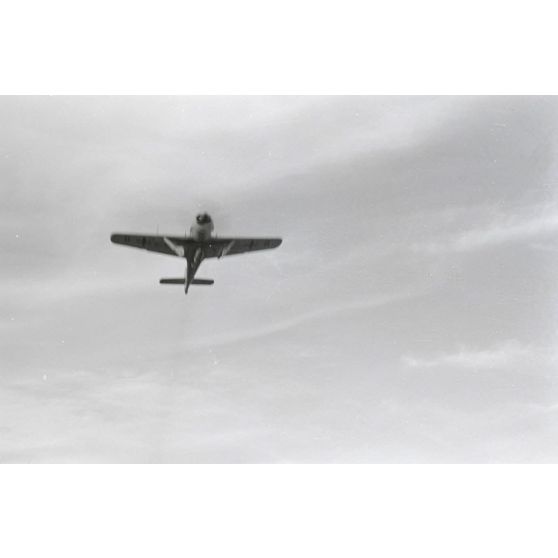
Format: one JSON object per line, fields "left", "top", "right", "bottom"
{"left": 110, "top": 213, "right": 283, "bottom": 294}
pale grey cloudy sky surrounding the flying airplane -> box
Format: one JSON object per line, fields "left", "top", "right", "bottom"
{"left": 0, "top": 96, "right": 558, "bottom": 463}
